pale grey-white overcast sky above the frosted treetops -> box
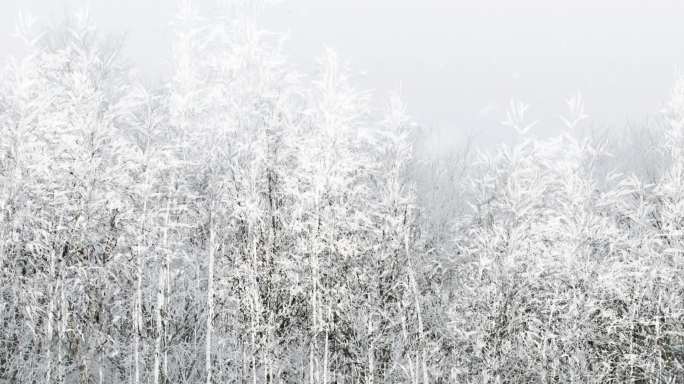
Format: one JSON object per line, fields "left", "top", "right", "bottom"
{"left": 0, "top": 0, "right": 684, "bottom": 147}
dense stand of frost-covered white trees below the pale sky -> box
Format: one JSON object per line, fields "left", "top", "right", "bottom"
{"left": 0, "top": 2, "right": 684, "bottom": 384}
